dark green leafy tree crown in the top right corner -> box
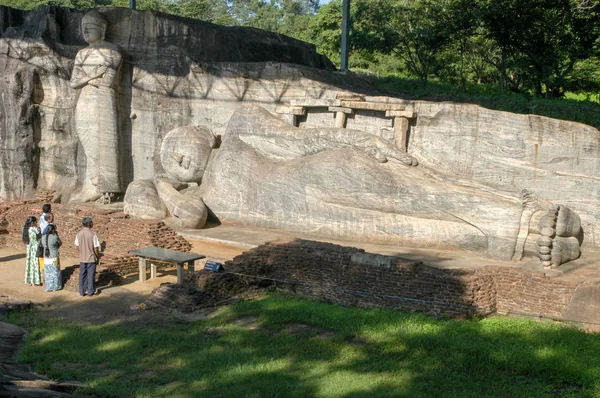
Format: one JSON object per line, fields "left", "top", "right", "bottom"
{"left": 476, "top": 0, "right": 600, "bottom": 97}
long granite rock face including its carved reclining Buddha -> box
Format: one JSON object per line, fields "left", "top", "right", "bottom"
{"left": 0, "top": 7, "right": 600, "bottom": 266}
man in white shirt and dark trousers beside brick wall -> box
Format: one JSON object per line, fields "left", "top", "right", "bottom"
{"left": 75, "top": 217, "right": 100, "bottom": 297}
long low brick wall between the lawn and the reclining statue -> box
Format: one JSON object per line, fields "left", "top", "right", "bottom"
{"left": 209, "top": 239, "right": 579, "bottom": 318}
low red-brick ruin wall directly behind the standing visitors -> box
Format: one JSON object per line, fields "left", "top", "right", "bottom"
{"left": 0, "top": 198, "right": 192, "bottom": 290}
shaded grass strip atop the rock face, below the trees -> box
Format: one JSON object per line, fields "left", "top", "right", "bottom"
{"left": 372, "top": 75, "right": 600, "bottom": 129}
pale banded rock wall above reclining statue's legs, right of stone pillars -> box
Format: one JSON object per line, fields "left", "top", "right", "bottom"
{"left": 408, "top": 102, "right": 600, "bottom": 247}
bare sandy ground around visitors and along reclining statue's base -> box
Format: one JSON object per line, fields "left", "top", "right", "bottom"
{"left": 0, "top": 225, "right": 600, "bottom": 323}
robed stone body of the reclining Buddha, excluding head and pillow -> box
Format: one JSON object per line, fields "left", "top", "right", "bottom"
{"left": 201, "top": 107, "right": 577, "bottom": 259}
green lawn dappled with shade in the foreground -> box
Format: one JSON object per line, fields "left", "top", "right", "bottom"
{"left": 11, "top": 294, "right": 600, "bottom": 398}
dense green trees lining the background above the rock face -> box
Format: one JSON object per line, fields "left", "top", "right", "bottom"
{"left": 0, "top": 0, "right": 600, "bottom": 98}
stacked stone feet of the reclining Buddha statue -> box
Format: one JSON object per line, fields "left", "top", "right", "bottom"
{"left": 538, "top": 205, "right": 581, "bottom": 267}
